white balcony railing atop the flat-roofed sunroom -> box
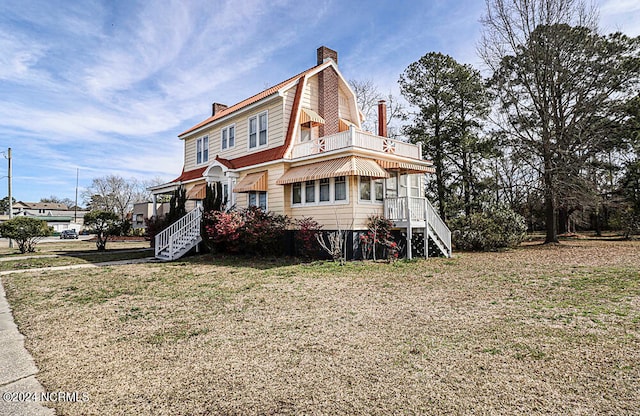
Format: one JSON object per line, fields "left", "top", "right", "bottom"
{"left": 291, "top": 127, "right": 422, "bottom": 159}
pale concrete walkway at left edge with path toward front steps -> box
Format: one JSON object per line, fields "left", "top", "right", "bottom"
{"left": 0, "top": 257, "right": 157, "bottom": 416}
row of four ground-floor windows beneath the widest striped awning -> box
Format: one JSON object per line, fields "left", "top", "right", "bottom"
{"left": 291, "top": 176, "right": 347, "bottom": 205}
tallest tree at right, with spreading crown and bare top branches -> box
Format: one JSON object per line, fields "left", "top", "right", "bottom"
{"left": 478, "top": 0, "right": 640, "bottom": 243}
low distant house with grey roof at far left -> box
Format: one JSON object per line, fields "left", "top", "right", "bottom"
{"left": 13, "top": 201, "right": 88, "bottom": 232}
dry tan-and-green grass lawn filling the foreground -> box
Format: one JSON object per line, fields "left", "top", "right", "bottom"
{"left": 2, "top": 240, "right": 640, "bottom": 415}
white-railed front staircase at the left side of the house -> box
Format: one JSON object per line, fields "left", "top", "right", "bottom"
{"left": 155, "top": 207, "right": 202, "bottom": 261}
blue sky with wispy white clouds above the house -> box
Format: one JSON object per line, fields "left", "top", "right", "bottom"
{"left": 0, "top": 0, "right": 640, "bottom": 206}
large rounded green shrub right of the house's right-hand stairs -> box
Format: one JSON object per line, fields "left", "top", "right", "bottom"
{"left": 450, "top": 207, "right": 527, "bottom": 251}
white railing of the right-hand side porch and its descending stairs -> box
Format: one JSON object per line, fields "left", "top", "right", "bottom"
{"left": 384, "top": 196, "right": 451, "bottom": 257}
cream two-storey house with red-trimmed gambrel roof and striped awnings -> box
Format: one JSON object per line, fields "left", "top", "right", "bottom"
{"left": 150, "top": 46, "right": 451, "bottom": 259}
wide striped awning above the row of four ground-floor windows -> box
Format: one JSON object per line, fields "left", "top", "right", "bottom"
{"left": 276, "top": 156, "right": 389, "bottom": 185}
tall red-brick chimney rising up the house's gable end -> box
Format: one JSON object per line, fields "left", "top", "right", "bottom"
{"left": 317, "top": 46, "right": 340, "bottom": 137}
